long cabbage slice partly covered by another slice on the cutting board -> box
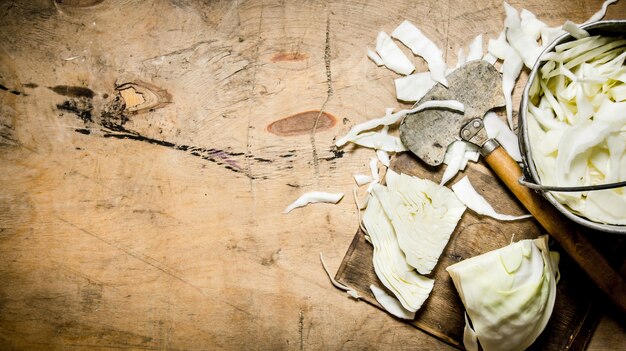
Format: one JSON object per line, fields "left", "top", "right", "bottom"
{"left": 363, "top": 191, "right": 434, "bottom": 312}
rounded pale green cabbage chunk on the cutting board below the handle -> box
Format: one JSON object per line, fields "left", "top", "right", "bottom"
{"left": 446, "top": 236, "right": 558, "bottom": 351}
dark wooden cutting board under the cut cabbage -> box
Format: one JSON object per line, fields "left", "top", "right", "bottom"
{"left": 335, "top": 153, "right": 616, "bottom": 350}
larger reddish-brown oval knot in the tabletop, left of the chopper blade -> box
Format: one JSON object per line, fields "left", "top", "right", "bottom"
{"left": 267, "top": 110, "right": 337, "bottom": 136}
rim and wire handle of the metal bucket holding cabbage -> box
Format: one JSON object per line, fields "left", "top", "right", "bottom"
{"left": 519, "top": 20, "right": 626, "bottom": 234}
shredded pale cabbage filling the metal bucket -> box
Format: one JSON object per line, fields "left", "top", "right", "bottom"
{"left": 528, "top": 33, "right": 626, "bottom": 225}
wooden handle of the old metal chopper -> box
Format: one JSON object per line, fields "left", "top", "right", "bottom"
{"left": 485, "top": 146, "right": 626, "bottom": 312}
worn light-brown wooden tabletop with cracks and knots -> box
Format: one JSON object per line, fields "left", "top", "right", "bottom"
{"left": 0, "top": 0, "right": 626, "bottom": 350}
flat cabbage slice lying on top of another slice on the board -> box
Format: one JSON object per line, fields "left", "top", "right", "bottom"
{"left": 372, "top": 170, "right": 465, "bottom": 274}
